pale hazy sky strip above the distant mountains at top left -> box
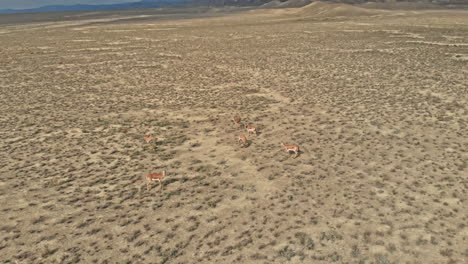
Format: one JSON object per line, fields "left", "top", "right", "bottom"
{"left": 0, "top": 0, "right": 139, "bottom": 9}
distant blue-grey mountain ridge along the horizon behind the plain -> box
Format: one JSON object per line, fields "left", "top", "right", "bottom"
{"left": 0, "top": 0, "right": 468, "bottom": 14}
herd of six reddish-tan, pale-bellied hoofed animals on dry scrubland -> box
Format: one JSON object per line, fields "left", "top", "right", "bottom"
{"left": 145, "top": 117, "right": 299, "bottom": 190}
